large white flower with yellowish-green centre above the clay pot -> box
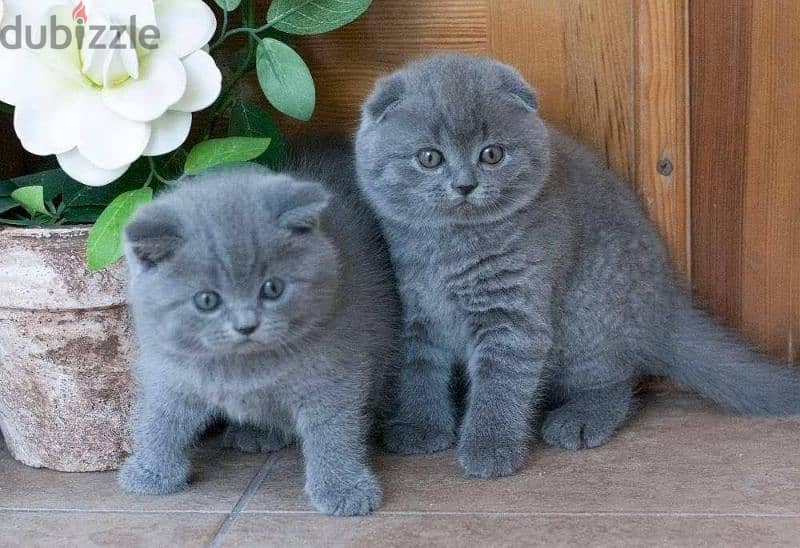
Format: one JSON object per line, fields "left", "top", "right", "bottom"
{"left": 0, "top": 0, "right": 222, "bottom": 186}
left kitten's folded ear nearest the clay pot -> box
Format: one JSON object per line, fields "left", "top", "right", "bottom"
{"left": 125, "top": 204, "right": 184, "bottom": 267}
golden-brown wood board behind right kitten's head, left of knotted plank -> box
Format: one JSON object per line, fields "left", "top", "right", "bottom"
{"left": 488, "top": 0, "right": 634, "bottom": 180}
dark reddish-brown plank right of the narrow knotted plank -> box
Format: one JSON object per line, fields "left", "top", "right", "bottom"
{"left": 689, "top": 0, "right": 752, "bottom": 327}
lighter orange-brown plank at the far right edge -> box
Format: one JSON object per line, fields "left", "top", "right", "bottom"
{"left": 742, "top": 0, "right": 800, "bottom": 360}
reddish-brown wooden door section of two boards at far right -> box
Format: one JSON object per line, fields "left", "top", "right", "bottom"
{"left": 690, "top": 0, "right": 800, "bottom": 362}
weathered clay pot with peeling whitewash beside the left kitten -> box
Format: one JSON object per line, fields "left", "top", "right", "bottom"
{"left": 0, "top": 227, "right": 132, "bottom": 472}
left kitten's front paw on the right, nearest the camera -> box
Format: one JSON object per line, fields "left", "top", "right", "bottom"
{"left": 306, "top": 470, "right": 382, "bottom": 516}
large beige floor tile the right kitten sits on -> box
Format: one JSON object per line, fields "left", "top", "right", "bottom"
{"left": 246, "top": 395, "right": 800, "bottom": 514}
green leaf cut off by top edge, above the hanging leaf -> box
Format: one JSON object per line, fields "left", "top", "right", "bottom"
{"left": 267, "top": 0, "right": 372, "bottom": 34}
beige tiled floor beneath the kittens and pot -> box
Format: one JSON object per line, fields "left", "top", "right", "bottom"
{"left": 0, "top": 395, "right": 800, "bottom": 547}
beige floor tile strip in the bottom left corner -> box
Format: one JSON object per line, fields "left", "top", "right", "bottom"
{"left": 0, "top": 512, "right": 225, "bottom": 548}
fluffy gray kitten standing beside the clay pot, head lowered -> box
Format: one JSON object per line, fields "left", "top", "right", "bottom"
{"left": 119, "top": 136, "right": 400, "bottom": 515}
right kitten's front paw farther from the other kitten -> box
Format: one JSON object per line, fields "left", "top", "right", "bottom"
{"left": 458, "top": 438, "right": 525, "bottom": 479}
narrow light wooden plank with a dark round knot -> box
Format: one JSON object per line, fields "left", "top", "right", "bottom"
{"left": 634, "top": 0, "right": 691, "bottom": 276}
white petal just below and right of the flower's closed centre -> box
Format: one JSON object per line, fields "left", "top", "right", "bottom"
{"left": 103, "top": 50, "right": 186, "bottom": 122}
